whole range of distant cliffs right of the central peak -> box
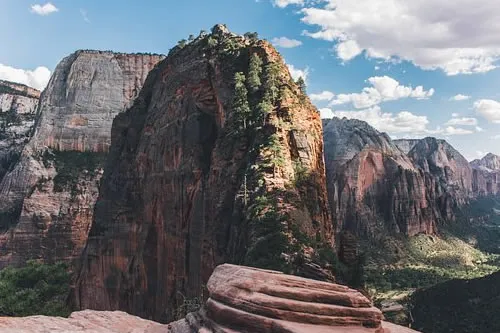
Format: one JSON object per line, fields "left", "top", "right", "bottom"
{"left": 323, "top": 118, "right": 500, "bottom": 237}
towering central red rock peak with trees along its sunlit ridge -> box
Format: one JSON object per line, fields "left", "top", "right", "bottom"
{"left": 75, "top": 25, "right": 333, "bottom": 321}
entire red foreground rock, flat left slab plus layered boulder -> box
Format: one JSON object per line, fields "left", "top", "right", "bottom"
{"left": 0, "top": 264, "right": 417, "bottom": 333}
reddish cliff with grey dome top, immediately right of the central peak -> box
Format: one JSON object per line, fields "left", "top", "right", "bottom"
{"left": 323, "top": 118, "right": 442, "bottom": 237}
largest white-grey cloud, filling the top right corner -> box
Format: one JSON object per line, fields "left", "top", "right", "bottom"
{"left": 296, "top": 0, "right": 500, "bottom": 75}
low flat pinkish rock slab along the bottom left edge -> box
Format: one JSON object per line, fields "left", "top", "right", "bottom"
{"left": 0, "top": 310, "right": 168, "bottom": 333}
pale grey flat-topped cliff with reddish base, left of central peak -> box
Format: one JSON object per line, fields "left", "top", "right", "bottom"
{"left": 0, "top": 51, "right": 163, "bottom": 267}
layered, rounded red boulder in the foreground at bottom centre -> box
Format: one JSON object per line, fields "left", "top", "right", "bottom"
{"left": 169, "top": 265, "right": 414, "bottom": 333}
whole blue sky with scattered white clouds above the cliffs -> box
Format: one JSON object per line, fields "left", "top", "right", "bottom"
{"left": 0, "top": 0, "right": 500, "bottom": 159}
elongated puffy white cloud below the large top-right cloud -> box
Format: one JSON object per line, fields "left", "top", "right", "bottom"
{"left": 331, "top": 76, "right": 434, "bottom": 109}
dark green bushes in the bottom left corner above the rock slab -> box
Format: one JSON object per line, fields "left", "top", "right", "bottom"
{"left": 0, "top": 261, "right": 71, "bottom": 317}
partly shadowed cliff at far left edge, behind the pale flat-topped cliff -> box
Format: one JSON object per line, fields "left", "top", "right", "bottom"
{"left": 0, "top": 80, "right": 40, "bottom": 181}
